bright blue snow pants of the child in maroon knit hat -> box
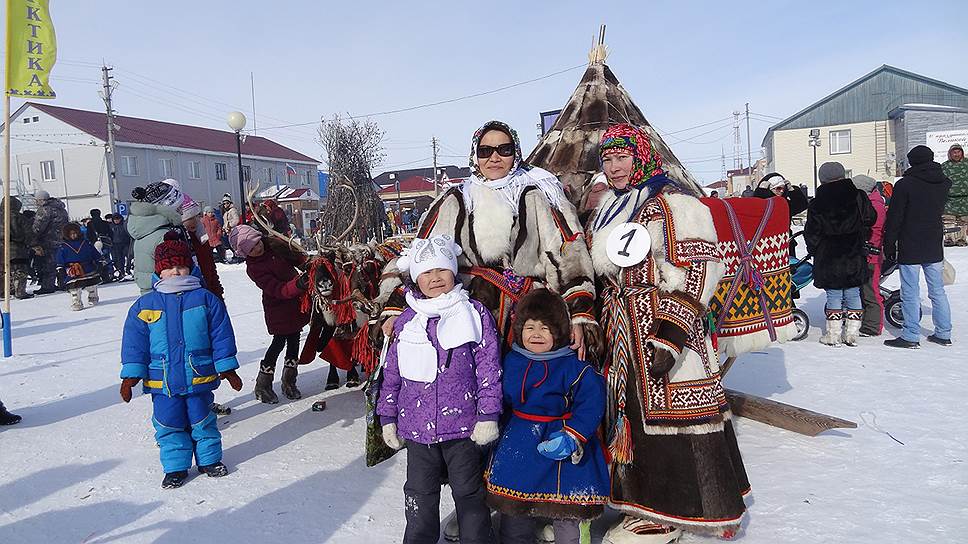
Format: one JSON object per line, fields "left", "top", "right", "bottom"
{"left": 151, "top": 391, "right": 222, "bottom": 473}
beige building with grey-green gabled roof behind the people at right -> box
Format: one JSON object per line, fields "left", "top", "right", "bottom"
{"left": 763, "top": 65, "right": 968, "bottom": 194}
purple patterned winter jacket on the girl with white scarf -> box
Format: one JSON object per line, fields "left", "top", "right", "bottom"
{"left": 376, "top": 300, "right": 502, "bottom": 444}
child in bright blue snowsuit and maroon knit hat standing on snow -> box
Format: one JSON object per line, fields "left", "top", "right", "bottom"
{"left": 121, "top": 234, "right": 242, "bottom": 489}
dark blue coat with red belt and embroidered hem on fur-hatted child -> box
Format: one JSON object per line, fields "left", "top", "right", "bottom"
{"left": 485, "top": 346, "right": 609, "bottom": 519}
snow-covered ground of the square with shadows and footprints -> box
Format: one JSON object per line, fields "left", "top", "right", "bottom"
{"left": 0, "top": 248, "right": 968, "bottom": 544}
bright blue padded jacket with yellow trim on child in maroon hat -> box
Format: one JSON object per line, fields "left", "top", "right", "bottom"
{"left": 121, "top": 276, "right": 239, "bottom": 396}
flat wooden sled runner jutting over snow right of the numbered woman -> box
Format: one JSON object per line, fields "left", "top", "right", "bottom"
{"left": 720, "top": 357, "right": 857, "bottom": 436}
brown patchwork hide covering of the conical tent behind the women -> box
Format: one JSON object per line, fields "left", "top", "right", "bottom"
{"left": 527, "top": 60, "right": 704, "bottom": 200}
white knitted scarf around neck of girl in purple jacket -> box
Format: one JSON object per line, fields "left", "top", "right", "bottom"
{"left": 397, "top": 284, "right": 484, "bottom": 383}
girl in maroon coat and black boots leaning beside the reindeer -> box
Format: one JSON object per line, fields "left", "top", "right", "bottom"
{"left": 229, "top": 225, "right": 309, "bottom": 404}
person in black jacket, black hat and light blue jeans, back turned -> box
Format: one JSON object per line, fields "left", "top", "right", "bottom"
{"left": 884, "top": 145, "right": 951, "bottom": 348}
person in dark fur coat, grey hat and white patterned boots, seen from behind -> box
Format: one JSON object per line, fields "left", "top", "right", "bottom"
{"left": 803, "top": 162, "right": 877, "bottom": 346}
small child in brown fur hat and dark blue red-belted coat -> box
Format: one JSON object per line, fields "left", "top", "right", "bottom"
{"left": 485, "top": 289, "right": 609, "bottom": 544}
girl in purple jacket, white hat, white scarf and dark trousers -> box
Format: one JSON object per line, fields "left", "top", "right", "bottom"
{"left": 376, "top": 235, "right": 502, "bottom": 544}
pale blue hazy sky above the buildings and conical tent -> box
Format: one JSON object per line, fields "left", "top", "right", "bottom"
{"left": 0, "top": 0, "right": 968, "bottom": 182}
